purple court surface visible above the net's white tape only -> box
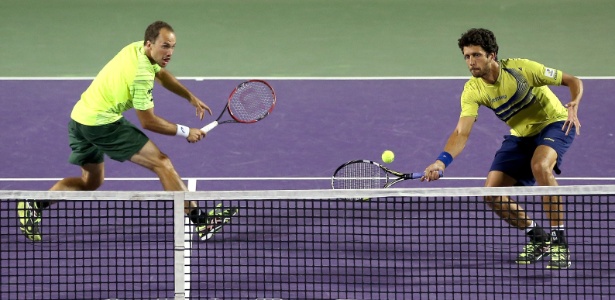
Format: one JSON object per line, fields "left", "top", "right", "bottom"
{"left": 0, "top": 79, "right": 615, "bottom": 190}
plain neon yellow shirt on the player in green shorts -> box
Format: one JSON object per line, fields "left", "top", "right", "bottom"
{"left": 70, "top": 41, "right": 161, "bottom": 126}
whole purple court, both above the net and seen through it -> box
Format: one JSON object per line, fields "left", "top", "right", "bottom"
{"left": 0, "top": 79, "right": 615, "bottom": 299}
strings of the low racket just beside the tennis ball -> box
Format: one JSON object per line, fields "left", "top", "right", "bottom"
{"left": 333, "top": 163, "right": 388, "bottom": 189}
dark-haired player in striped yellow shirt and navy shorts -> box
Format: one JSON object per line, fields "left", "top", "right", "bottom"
{"left": 421, "top": 28, "right": 583, "bottom": 269}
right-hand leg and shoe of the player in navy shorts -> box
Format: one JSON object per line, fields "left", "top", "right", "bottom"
{"left": 532, "top": 145, "right": 571, "bottom": 269}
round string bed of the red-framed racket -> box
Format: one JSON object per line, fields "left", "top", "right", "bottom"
{"left": 229, "top": 81, "right": 275, "bottom": 123}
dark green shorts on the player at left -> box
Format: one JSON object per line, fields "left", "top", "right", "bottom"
{"left": 68, "top": 118, "right": 149, "bottom": 166}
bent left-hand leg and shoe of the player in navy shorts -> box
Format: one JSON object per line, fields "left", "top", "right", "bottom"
{"left": 485, "top": 171, "right": 549, "bottom": 264}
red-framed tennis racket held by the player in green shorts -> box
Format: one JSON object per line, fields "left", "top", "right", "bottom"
{"left": 201, "top": 80, "right": 275, "bottom": 133}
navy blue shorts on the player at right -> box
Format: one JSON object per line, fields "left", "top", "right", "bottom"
{"left": 490, "top": 121, "right": 576, "bottom": 186}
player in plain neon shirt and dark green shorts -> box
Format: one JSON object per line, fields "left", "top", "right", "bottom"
{"left": 17, "top": 21, "right": 237, "bottom": 241}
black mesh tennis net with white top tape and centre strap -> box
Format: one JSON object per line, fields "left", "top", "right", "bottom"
{"left": 0, "top": 185, "right": 615, "bottom": 299}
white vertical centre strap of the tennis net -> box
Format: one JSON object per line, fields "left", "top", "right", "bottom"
{"left": 173, "top": 192, "right": 186, "bottom": 300}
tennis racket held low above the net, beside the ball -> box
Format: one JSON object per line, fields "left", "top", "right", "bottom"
{"left": 331, "top": 160, "right": 442, "bottom": 189}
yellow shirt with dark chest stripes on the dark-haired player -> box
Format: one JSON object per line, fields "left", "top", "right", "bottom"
{"left": 460, "top": 59, "right": 568, "bottom": 137}
